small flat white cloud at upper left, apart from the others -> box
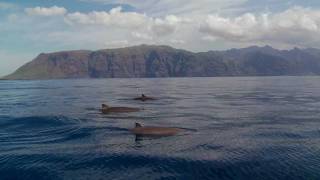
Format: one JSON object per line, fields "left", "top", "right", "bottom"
{"left": 25, "top": 6, "right": 67, "bottom": 16}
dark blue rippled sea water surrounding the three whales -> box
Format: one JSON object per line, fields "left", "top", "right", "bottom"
{"left": 0, "top": 77, "right": 320, "bottom": 180}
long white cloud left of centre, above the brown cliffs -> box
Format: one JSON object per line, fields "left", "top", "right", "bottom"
{"left": 65, "top": 7, "right": 190, "bottom": 39}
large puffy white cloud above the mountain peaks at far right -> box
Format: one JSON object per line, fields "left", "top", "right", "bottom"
{"left": 199, "top": 7, "right": 320, "bottom": 46}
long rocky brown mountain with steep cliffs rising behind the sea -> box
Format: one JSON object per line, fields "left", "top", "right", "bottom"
{"left": 4, "top": 45, "right": 320, "bottom": 79}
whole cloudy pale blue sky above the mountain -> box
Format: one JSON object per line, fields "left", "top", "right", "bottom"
{"left": 0, "top": 0, "right": 320, "bottom": 76}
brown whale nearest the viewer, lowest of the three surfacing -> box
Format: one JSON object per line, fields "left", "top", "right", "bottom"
{"left": 130, "top": 123, "right": 183, "bottom": 137}
